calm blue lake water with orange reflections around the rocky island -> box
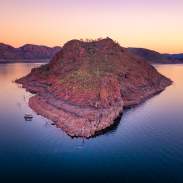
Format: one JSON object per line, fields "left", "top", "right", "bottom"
{"left": 0, "top": 64, "right": 183, "bottom": 182}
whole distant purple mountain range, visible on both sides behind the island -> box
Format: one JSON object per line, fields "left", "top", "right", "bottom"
{"left": 0, "top": 43, "right": 183, "bottom": 63}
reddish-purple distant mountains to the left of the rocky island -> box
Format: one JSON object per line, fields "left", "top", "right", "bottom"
{"left": 0, "top": 43, "right": 61, "bottom": 62}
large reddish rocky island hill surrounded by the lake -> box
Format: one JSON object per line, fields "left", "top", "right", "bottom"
{"left": 16, "top": 38, "right": 172, "bottom": 138}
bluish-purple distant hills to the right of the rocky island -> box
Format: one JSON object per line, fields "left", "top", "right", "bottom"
{"left": 127, "top": 48, "right": 183, "bottom": 64}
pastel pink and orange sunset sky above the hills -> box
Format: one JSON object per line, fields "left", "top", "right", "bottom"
{"left": 0, "top": 0, "right": 183, "bottom": 53}
